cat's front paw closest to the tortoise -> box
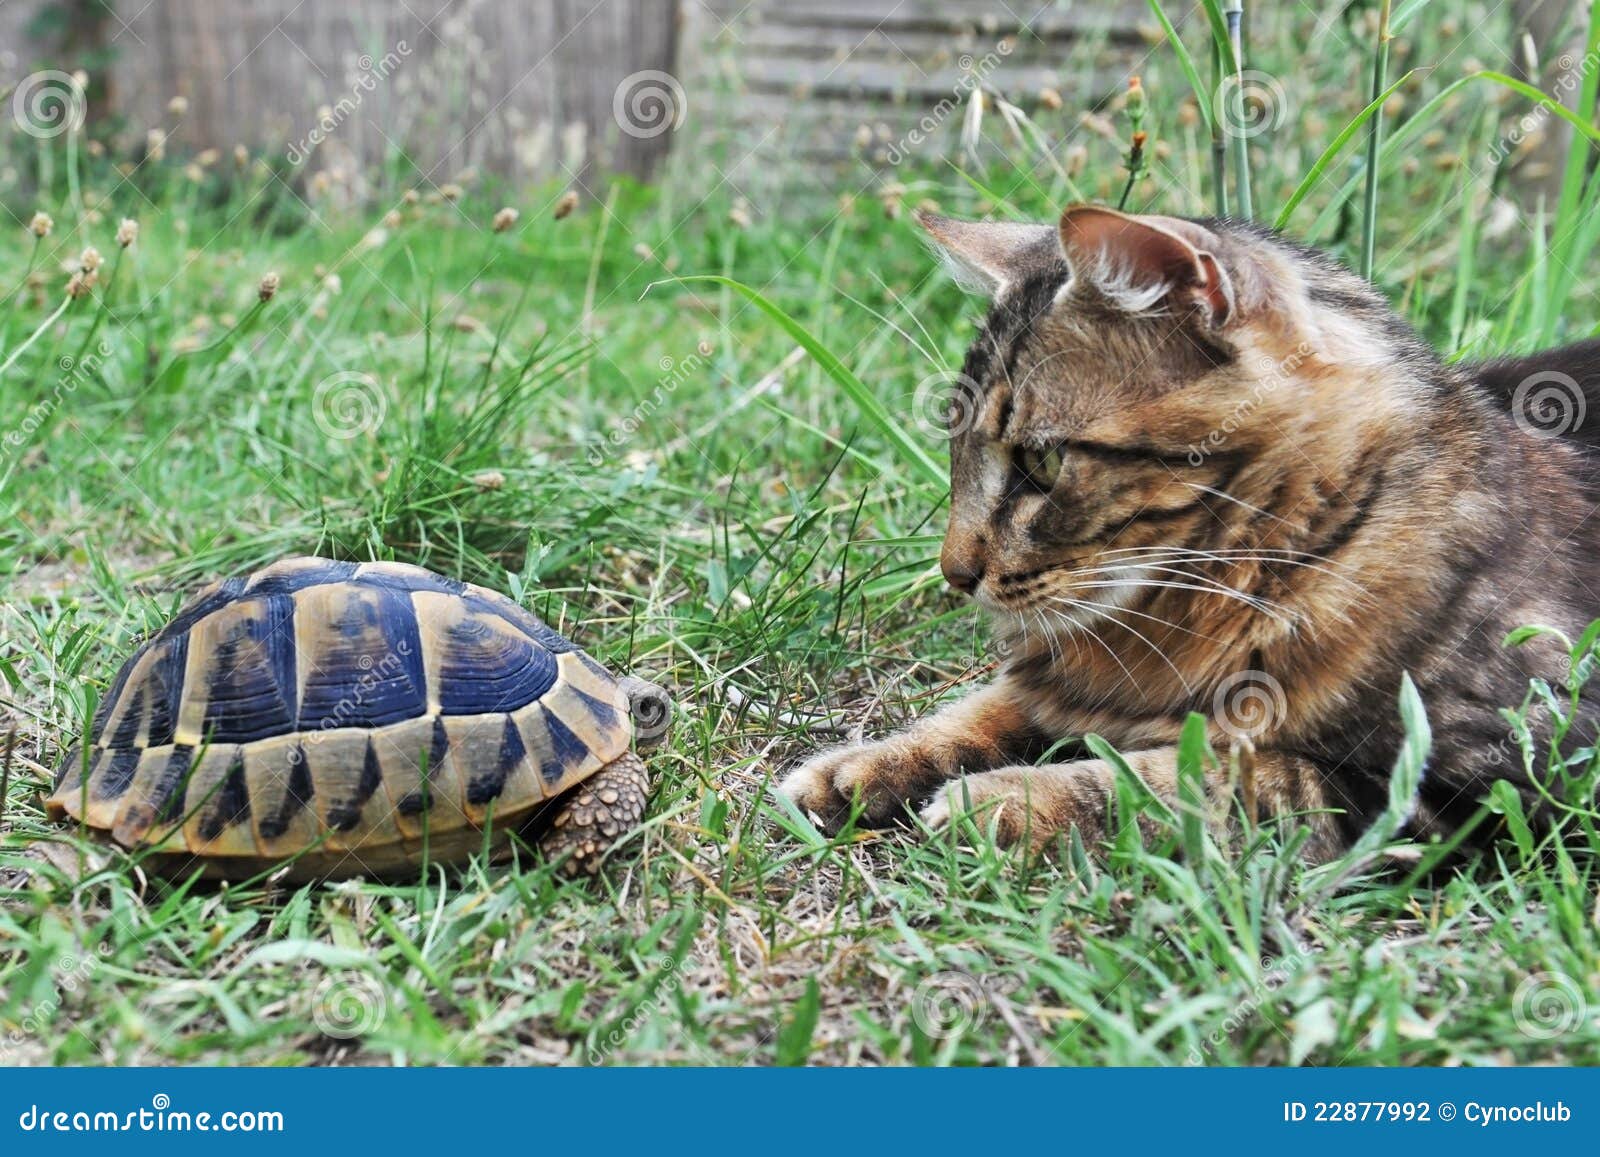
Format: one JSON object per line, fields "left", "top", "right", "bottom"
{"left": 778, "top": 739, "right": 942, "bottom": 831}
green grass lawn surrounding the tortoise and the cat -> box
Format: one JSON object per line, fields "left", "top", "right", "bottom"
{"left": 0, "top": 5, "right": 1600, "bottom": 1064}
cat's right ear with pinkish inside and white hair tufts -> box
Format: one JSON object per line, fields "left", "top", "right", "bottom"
{"left": 1059, "top": 205, "right": 1234, "bottom": 328}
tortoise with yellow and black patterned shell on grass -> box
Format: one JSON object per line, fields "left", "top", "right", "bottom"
{"left": 45, "top": 558, "right": 672, "bottom": 880}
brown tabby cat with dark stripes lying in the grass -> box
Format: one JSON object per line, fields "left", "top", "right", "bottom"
{"left": 779, "top": 205, "right": 1600, "bottom": 863}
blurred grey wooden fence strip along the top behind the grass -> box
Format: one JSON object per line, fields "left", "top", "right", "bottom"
{"left": 0, "top": 0, "right": 1581, "bottom": 204}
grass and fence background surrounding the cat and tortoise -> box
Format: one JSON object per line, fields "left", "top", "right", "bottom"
{"left": 0, "top": 0, "right": 1600, "bottom": 1066}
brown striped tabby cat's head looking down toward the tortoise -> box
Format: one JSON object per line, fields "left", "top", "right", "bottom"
{"left": 918, "top": 205, "right": 1394, "bottom": 633}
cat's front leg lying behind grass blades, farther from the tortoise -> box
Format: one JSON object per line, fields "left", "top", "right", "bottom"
{"left": 922, "top": 747, "right": 1362, "bottom": 864}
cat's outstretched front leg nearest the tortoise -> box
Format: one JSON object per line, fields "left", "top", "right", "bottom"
{"left": 778, "top": 675, "right": 1040, "bottom": 827}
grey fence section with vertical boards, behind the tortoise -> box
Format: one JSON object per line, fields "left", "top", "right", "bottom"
{"left": 0, "top": 0, "right": 680, "bottom": 182}
